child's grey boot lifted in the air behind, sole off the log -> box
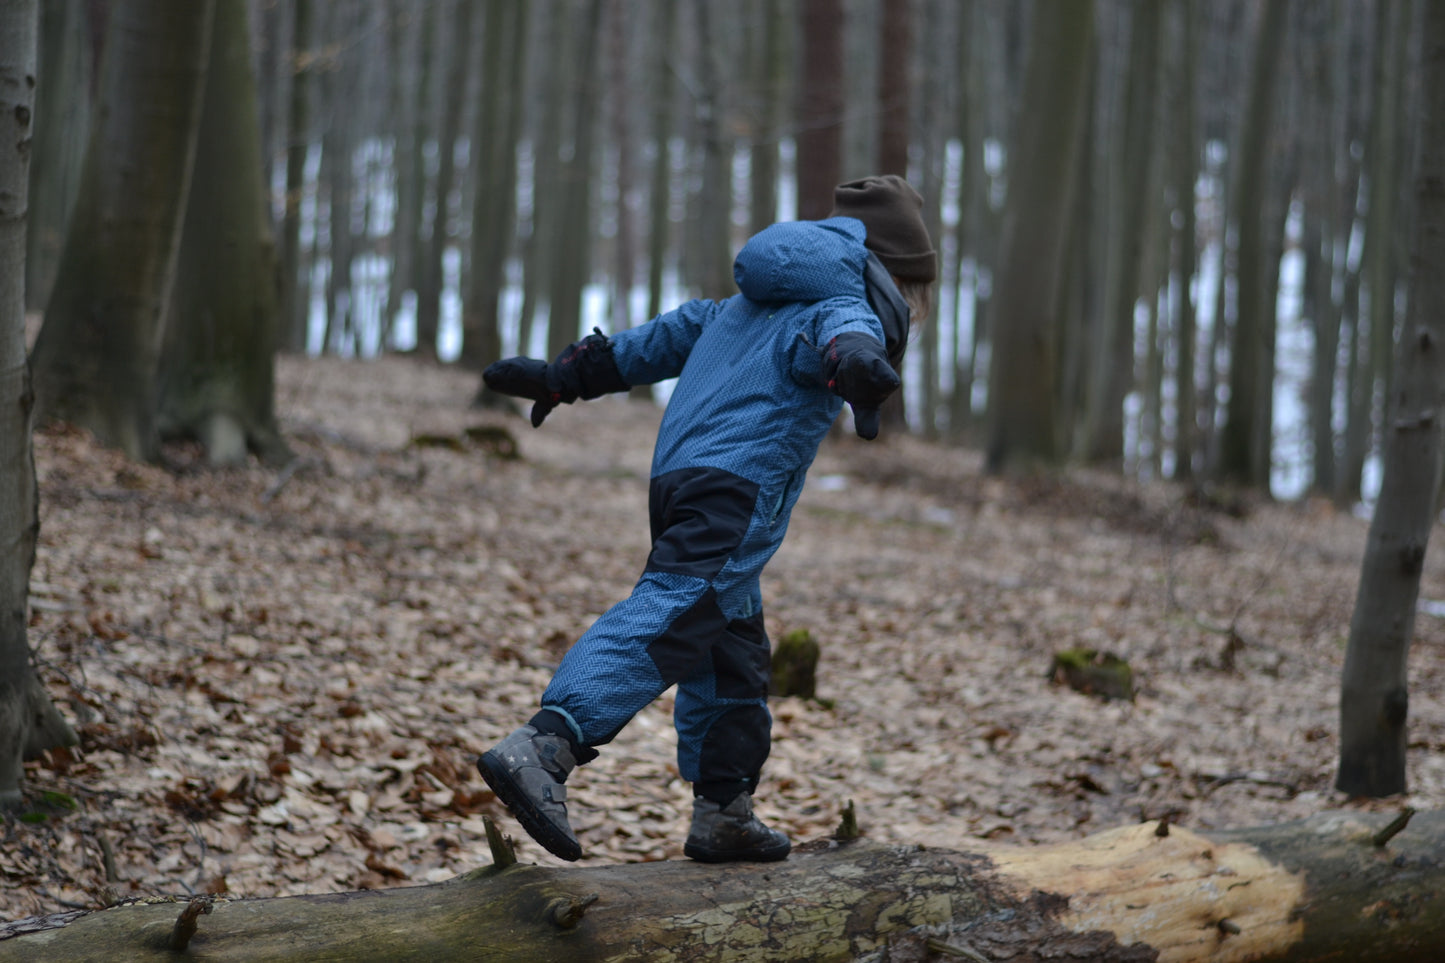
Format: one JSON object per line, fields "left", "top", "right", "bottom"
{"left": 477, "top": 726, "right": 582, "bottom": 860}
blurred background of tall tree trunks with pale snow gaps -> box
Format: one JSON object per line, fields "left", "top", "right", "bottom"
{"left": 26, "top": 0, "right": 1423, "bottom": 494}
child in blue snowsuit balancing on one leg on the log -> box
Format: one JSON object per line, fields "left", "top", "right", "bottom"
{"left": 477, "top": 175, "right": 936, "bottom": 862}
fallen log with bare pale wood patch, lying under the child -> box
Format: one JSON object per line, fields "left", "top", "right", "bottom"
{"left": 0, "top": 813, "right": 1445, "bottom": 963}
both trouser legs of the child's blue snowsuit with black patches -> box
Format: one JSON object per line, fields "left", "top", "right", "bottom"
{"left": 542, "top": 468, "right": 776, "bottom": 789}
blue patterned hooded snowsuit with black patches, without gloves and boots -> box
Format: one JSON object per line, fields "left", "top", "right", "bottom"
{"left": 542, "top": 217, "right": 906, "bottom": 791}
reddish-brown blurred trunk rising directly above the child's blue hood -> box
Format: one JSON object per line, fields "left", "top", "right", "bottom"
{"left": 798, "top": 0, "right": 844, "bottom": 221}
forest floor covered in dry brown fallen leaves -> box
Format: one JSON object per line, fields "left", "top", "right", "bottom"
{"left": 8, "top": 357, "right": 1445, "bottom": 918}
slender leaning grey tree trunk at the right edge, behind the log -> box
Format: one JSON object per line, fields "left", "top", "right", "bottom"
{"left": 1335, "top": 3, "right": 1445, "bottom": 795}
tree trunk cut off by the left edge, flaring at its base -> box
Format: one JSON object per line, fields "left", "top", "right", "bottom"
{"left": 0, "top": 0, "right": 75, "bottom": 807}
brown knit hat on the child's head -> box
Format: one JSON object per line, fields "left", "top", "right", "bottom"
{"left": 829, "top": 174, "right": 938, "bottom": 282}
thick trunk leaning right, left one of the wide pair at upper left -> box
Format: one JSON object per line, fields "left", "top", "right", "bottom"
{"left": 32, "top": 0, "right": 212, "bottom": 460}
